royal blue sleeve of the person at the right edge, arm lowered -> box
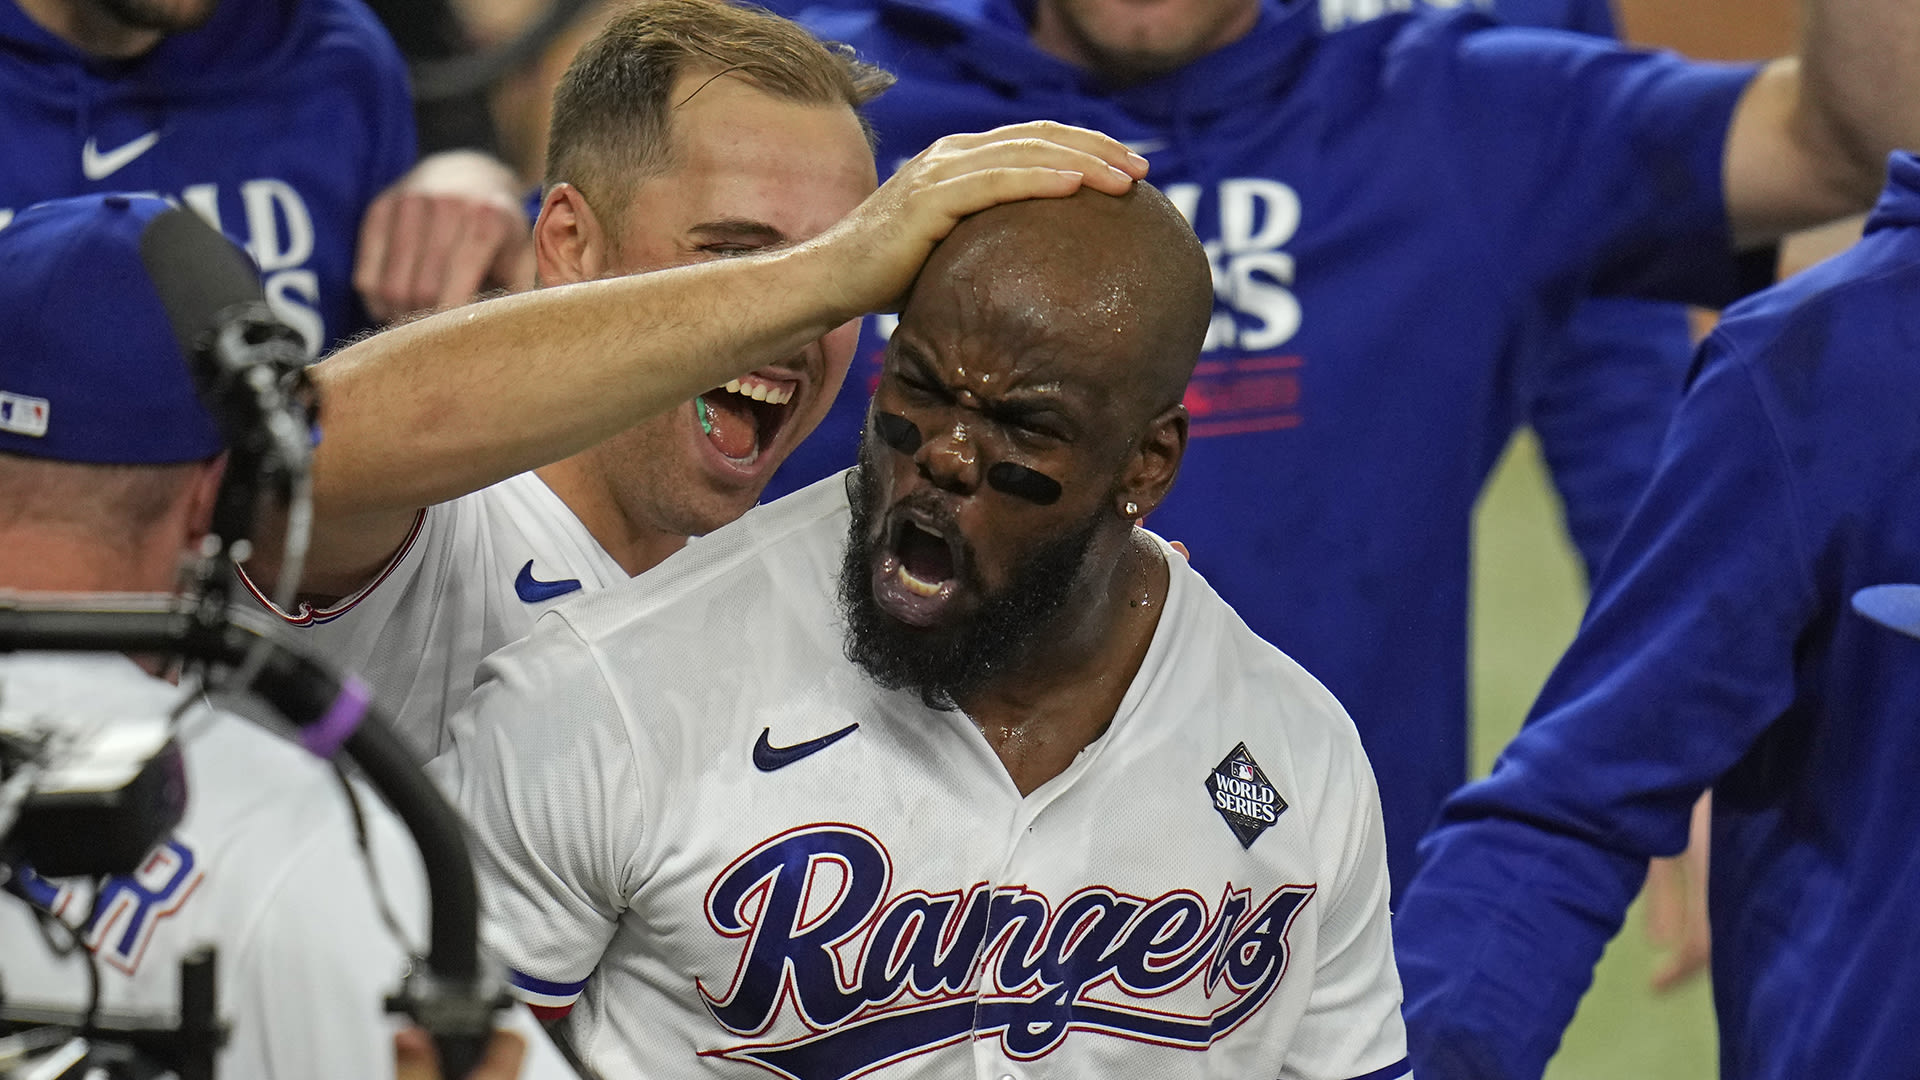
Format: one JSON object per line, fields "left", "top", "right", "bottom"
{"left": 1394, "top": 336, "right": 1814, "bottom": 1080}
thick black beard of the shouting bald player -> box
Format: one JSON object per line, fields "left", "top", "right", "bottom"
{"left": 839, "top": 446, "right": 1100, "bottom": 709}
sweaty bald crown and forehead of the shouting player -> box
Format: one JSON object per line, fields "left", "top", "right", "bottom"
{"left": 900, "top": 181, "right": 1213, "bottom": 421}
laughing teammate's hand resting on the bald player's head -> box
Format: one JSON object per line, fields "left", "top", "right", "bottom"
{"left": 802, "top": 121, "right": 1146, "bottom": 317}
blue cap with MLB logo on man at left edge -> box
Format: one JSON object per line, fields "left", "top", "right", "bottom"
{"left": 0, "top": 194, "right": 225, "bottom": 465}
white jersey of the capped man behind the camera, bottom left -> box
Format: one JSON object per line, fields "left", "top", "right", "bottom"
{"left": 0, "top": 653, "right": 572, "bottom": 1080}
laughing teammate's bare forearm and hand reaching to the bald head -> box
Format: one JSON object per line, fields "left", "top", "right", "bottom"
{"left": 313, "top": 121, "right": 1146, "bottom": 518}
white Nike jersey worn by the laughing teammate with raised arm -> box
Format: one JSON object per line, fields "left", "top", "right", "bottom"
{"left": 253, "top": 473, "right": 628, "bottom": 761}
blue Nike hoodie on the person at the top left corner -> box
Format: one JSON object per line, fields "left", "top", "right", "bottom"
{"left": 0, "top": 0, "right": 413, "bottom": 354}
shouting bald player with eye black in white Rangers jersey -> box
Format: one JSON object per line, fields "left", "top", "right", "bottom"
{"left": 436, "top": 184, "right": 1407, "bottom": 1080}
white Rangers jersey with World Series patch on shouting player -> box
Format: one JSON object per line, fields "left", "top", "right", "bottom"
{"left": 436, "top": 477, "right": 1409, "bottom": 1080}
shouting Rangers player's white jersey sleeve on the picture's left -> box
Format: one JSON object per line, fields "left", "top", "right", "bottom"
{"left": 432, "top": 619, "right": 645, "bottom": 1019}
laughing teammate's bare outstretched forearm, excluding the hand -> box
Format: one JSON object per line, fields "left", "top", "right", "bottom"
{"left": 313, "top": 246, "right": 858, "bottom": 519}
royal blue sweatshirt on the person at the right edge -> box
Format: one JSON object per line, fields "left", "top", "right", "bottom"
{"left": 1394, "top": 156, "right": 1920, "bottom": 1080}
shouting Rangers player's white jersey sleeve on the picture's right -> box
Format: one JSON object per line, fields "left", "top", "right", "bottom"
{"left": 1281, "top": 724, "right": 1413, "bottom": 1080}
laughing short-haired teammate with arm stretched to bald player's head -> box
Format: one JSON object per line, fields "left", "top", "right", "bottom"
{"left": 234, "top": 0, "right": 1144, "bottom": 761}
